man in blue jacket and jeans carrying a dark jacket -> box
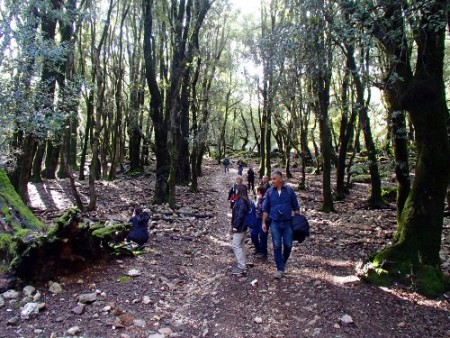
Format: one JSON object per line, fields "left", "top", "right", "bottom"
{"left": 262, "top": 170, "right": 300, "bottom": 279}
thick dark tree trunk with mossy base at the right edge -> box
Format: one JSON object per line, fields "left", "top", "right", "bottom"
{"left": 356, "top": 1, "right": 450, "bottom": 296}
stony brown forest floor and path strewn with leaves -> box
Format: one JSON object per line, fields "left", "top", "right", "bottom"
{"left": 0, "top": 165, "right": 450, "bottom": 338}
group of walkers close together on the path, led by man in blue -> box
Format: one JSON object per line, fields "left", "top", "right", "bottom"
{"left": 228, "top": 166, "right": 306, "bottom": 279}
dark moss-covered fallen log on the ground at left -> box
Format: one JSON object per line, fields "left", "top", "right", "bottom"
{"left": 10, "top": 208, "right": 131, "bottom": 280}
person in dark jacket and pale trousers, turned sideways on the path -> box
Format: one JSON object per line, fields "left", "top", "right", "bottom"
{"left": 231, "top": 184, "right": 250, "bottom": 276}
